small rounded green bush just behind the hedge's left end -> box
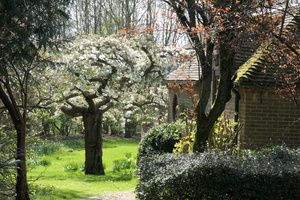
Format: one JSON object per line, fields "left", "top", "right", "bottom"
{"left": 138, "top": 122, "right": 184, "bottom": 158}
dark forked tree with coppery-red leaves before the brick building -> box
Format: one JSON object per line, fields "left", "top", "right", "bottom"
{"left": 162, "top": 0, "right": 298, "bottom": 152}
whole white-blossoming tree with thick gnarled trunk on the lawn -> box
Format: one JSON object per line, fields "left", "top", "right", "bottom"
{"left": 52, "top": 35, "right": 170, "bottom": 174}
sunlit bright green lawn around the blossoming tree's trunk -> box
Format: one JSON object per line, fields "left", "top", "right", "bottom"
{"left": 28, "top": 139, "right": 139, "bottom": 200}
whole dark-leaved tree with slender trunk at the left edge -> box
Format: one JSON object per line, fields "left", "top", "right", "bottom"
{"left": 0, "top": 0, "right": 69, "bottom": 200}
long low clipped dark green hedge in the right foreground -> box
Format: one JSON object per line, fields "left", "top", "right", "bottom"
{"left": 136, "top": 147, "right": 300, "bottom": 200}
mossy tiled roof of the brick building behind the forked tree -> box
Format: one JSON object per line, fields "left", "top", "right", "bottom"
{"left": 165, "top": 8, "right": 299, "bottom": 85}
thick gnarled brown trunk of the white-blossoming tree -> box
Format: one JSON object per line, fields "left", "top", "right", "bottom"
{"left": 83, "top": 110, "right": 105, "bottom": 175}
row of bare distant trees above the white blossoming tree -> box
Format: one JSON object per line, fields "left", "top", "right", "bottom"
{"left": 71, "top": 0, "right": 179, "bottom": 45}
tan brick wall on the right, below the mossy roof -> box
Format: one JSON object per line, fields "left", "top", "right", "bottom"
{"left": 238, "top": 86, "right": 300, "bottom": 149}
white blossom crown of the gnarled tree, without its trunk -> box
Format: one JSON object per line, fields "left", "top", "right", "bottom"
{"left": 49, "top": 35, "right": 170, "bottom": 115}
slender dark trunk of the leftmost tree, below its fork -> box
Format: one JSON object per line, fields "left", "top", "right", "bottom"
{"left": 15, "top": 122, "right": 30, "bottom": 200}
